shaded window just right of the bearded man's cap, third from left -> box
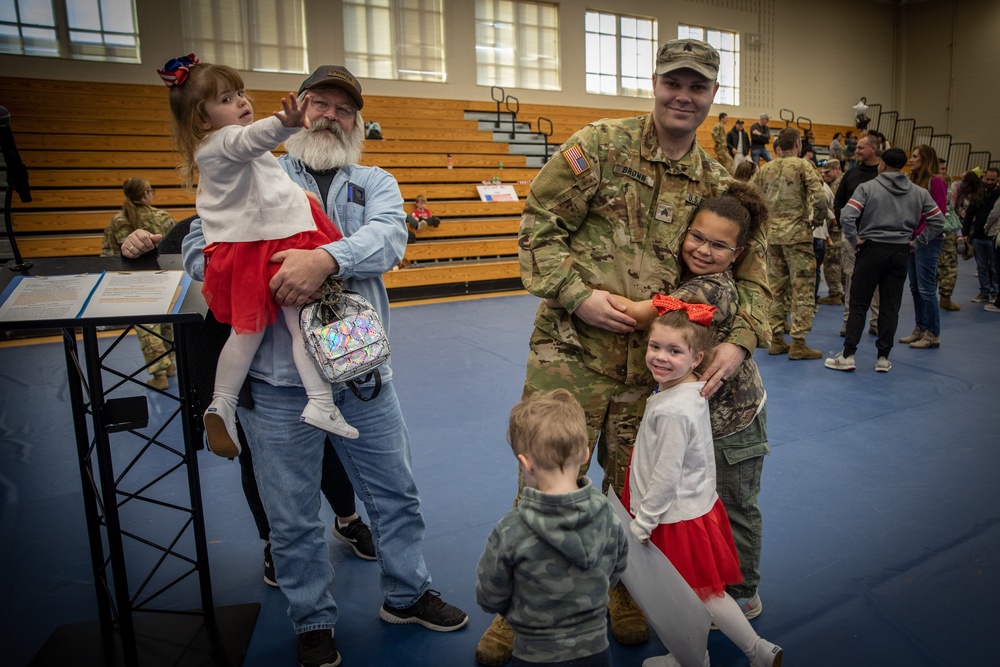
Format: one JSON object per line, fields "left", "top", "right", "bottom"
{"left": 344, "top": 0, "right": 447, "bottom": 82}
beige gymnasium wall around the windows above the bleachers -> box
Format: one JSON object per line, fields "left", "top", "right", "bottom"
{"left": 0, "top": 0, "right": 1000, "bottom": 155}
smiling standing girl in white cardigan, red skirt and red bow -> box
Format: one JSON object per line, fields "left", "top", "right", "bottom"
{"left": 622, "top": 295, "right": 781, "bottom": 667}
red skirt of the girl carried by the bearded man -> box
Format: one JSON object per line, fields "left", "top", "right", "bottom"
{"left": 201, "top": 198, "right": 344, "bottom": 334}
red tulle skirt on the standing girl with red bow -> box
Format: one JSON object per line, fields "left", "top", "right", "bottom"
{"left": 622, "top": 467, "right": 743, "bottom": 600}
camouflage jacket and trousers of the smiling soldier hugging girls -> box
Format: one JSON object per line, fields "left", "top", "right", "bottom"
{"left": 518, "top": 115, "right": 770, "bottom": 495}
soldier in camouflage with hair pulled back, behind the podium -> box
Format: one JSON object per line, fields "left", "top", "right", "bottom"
{"left": 101, "top": 177, "right": 177, "bottom": 389}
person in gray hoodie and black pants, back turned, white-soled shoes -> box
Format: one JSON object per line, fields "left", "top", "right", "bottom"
{"left": 826, "top": 148, "right": 944, "bottom": 373}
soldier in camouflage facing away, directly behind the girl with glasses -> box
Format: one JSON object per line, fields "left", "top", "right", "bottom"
{"left": 750, "top": 127, "right": 827, "bottom": 359}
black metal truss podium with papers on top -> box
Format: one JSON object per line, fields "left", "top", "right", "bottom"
{"left": 0, "top": 253, "right": 260, "bottom": 667}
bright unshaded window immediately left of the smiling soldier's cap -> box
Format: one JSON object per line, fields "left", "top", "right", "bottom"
{"left": 586, "top": 12, "right": 657, "bottom": 97}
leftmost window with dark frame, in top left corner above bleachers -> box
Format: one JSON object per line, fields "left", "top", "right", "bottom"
{"left": 0, "top": 0, "right": 139, "bottom": 63}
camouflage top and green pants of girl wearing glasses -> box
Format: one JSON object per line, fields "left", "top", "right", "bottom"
{"left": 671, "top": 271, "right": 771, "bottom": 599}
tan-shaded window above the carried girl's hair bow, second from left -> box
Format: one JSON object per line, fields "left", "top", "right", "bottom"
{"left": 180, "top": 0, "right": 307, "bottom": 74}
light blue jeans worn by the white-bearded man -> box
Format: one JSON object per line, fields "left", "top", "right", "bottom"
{"left": 239, "top": 381, "right": 431, "bottom": 634}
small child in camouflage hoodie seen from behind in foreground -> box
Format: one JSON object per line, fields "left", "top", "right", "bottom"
{"left": 476, "top": 389, "right": 628, "bottom": 667}
